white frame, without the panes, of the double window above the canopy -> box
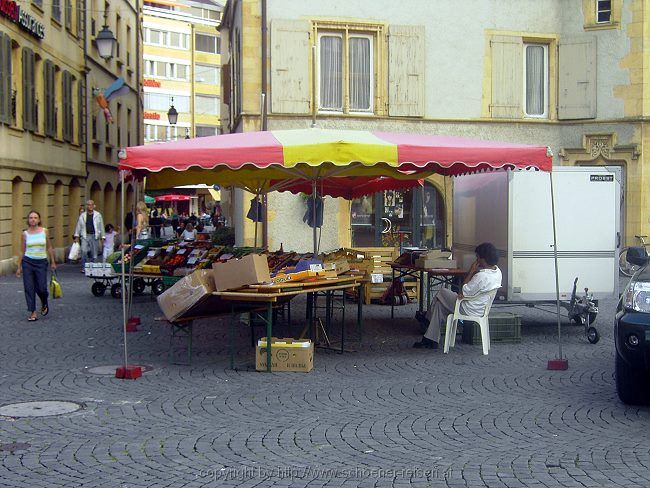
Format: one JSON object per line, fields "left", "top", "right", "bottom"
{"left": 315, "top": 29, "right": 377, "bottom": 115}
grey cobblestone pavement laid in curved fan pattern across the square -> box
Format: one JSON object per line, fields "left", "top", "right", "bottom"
{"left": 0, "top": 266, "right": 650, "bottom": 488}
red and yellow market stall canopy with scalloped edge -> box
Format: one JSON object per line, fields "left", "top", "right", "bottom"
{"left": 120, "top": 129, "right": 552, "bottom": 193}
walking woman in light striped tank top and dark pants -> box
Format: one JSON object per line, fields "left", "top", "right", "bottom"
{"left": 16, "top": 210, "right": 56, "bottom": 322}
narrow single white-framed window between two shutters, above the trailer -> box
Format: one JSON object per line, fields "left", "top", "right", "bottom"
{"left": 524, "top": 44, "right": 548, "bottom": 118}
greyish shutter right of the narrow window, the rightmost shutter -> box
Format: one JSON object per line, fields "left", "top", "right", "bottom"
{"left": 558, "top": 36, "right": 597, "bottom": 119}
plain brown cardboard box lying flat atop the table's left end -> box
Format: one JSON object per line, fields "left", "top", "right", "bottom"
{"left": 212, "top": 254, "right": 271, "bottom": 291}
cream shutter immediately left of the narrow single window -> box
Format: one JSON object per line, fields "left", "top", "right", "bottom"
{"left": 490, "top": 36, "right": 523, "bottom": 119}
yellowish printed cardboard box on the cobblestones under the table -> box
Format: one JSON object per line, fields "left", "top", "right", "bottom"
{"left": 255, "top": 337, "right": 314, "bottom": 373}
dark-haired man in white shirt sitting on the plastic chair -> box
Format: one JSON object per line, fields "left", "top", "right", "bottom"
{"left": 413, "top": 242, "right": 502, "bottom": 349}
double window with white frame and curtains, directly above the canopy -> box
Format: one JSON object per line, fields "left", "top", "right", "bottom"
{"left": 317, "top": 30, "right": 375, "bottom": 113}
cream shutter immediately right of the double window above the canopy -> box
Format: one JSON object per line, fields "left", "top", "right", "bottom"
{"left": 388, "top": 25, "right": 425, "bottom": 117}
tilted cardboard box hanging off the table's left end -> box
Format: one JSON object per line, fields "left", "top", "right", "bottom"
{"left": 158, "top": 269, "right": 215, "bottom": 322}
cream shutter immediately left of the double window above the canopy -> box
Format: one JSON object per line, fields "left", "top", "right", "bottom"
{"left": 271, "top": 19, "right": 311, "bottom": 114}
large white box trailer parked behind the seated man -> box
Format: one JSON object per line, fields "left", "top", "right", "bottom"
{"left": 452, "top": 166, "right": 621, "bottom": 334}
